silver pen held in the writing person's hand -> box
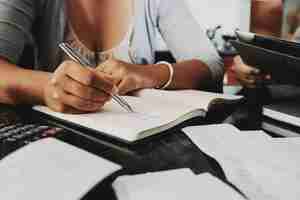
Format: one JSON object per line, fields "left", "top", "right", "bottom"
{"left": 59, "top": 42, "right": 134, "bottom": 112}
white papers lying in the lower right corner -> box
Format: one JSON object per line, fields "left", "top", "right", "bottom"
{"left": 184, "top": 124, "right": 300, "bottom": 200}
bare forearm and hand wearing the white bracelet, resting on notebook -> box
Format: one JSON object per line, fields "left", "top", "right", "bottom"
{"left": 96, "top": 59, "right": 215, "bottom": 95}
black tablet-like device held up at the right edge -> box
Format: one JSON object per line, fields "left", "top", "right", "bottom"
{"left": 231, "top": 32, "right": 300, "bottom": 85}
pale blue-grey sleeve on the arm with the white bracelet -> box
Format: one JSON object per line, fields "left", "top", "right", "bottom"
{"left": 156, "top": 0, "right": 224, "bottom": 82}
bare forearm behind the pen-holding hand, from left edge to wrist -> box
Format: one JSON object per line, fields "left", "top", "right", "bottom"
{"left": 0, "top": 60, "right": 51, "bottom": 105}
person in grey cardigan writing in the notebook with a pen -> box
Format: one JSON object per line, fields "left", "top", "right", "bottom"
{"left": 0, "top": 0, "right": 223, "bottom": 113}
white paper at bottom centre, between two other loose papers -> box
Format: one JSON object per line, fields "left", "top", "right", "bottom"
{"left": 113, "top": 169, "right": 244, "bottom": 200}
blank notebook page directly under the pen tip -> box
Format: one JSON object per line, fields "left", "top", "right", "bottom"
{"left": 34, "top": 96, "right": 198, "bottom": 141}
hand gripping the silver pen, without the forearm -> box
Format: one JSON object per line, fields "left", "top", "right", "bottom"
{"left": 44, "top": 61, "right": 116, "bottom": 113}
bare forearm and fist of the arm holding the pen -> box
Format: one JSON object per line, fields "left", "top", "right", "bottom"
{"left": 0, "top": 59, "right": 115, "bottom": 113}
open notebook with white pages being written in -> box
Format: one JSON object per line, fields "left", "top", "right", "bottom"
{"left": 33, "top": 89, "right": 241, "bottom": 143}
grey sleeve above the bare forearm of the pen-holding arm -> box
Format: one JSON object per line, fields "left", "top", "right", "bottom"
{"left": 0, "top": 0, "right": 39, "bottom": 64}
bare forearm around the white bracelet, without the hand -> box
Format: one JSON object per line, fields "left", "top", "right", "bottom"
{"left": 153, "top": 60, "right": 214, "bottom": 89}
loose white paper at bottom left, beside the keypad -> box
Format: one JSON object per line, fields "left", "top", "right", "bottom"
{"left": 0, "top": 138, "right": 120, "bottom": 200}
